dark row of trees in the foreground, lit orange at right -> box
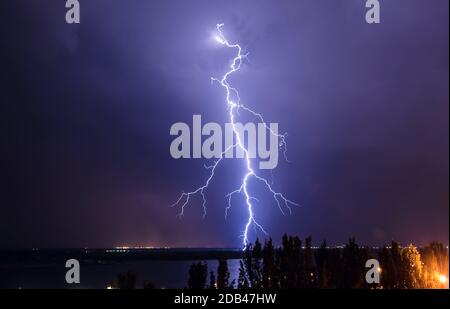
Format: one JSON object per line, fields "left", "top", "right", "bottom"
{"left": 187, "top": 235, "right": 449, "bottom": 289}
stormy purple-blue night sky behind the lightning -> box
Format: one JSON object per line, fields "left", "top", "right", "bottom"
{"left": 0, "top": 0, "right": 449, "bottom": 247}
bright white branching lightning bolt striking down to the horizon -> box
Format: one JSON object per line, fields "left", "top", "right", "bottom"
{"left": 171, "top": 24, "right": 298, "bottom": 249}
